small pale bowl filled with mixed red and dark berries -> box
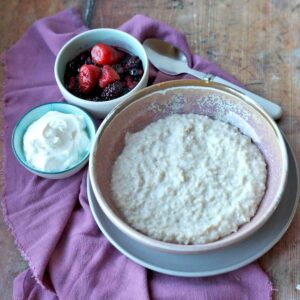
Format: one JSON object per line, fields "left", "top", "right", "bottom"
{"left": 54, "top": 28, "right": 149, "bottom": 118}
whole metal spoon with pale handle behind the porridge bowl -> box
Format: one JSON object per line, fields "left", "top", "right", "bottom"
{"left": 143, "top": 39, "right": 282, "bottom": 120}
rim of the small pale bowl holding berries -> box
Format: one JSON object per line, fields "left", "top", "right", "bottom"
{"left": 54, "top": 27, "right": 149, "bottom": 108}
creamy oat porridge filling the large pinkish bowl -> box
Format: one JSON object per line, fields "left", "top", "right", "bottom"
{"left": 111, "top": 114, "right": 267, "bottom": 244}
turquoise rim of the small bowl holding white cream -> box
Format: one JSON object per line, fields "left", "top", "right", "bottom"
{"left": 11, "top": 101, "right": 96, "bottom": 175}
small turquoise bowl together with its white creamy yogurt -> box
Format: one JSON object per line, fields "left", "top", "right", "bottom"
{"left": 12, "top": 102, "right": 95, "bottom": 179}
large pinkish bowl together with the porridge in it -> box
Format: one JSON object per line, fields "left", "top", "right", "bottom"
{"left": 89, "top": 80, "right": 287, "bottom": 253}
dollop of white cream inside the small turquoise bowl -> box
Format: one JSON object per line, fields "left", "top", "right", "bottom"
{"left": 23, "top": 111, "right": 90, "bottom": 172}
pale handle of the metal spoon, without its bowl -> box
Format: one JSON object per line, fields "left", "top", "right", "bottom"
{"left": 185, "top": 68, "right": 282, "bottom": 120}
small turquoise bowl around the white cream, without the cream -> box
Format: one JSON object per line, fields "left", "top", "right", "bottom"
{"left": 11, "top": 102, "right": 96, "bottom": 179}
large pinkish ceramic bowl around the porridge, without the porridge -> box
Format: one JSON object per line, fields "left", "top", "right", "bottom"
{"left": 89, "top": 80, "right": 288, "bottom": 254}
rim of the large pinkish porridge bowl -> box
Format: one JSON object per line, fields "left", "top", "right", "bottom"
{"left": 89, "top": 79, "right": 288, "bottom": 254}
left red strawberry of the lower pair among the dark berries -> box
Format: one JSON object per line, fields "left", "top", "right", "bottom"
{"left": 79, "top": 65, "right": 101, "bottom": 94}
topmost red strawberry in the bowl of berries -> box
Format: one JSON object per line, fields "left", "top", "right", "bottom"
{"left": 91, "top": 44, "right": 124, "bottom": 65}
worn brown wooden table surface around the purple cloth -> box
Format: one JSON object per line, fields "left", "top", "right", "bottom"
{"left": 0, "top": 0, "right": 300, "bottom": 300}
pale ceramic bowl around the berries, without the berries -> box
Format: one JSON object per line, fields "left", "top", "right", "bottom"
{"left": 54, "top": 28, "right": 149, "bottom": 118}
